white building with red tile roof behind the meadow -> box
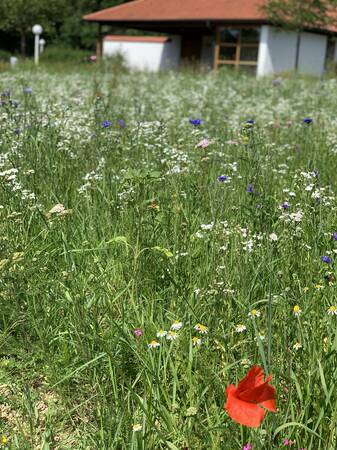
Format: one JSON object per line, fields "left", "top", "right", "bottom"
{"left": 84, "top": 0, "right": 337, "bottom": 76}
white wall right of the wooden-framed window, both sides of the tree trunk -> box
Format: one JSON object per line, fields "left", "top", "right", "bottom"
{"left": 257, "top": 25, "right": 327, "bottom": 76}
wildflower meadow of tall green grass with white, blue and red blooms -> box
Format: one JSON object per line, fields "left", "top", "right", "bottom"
{"left": 0, "top": 65, "right": 337, "bottom": 450}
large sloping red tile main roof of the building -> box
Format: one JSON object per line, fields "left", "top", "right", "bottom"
{"left": 84, "top": 0, "right": 265, "bottom": 22}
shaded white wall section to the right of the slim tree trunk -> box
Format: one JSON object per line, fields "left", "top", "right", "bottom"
{"left": 298, "top": 33, "right": 327, "bottom": 76}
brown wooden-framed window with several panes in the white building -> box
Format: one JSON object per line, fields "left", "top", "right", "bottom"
{"left": 214, "top": 27, "right": 260, "bottom": 70}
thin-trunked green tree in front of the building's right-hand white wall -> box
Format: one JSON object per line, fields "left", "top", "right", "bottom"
{"left": 262, "top": 0, "right": 337, "bottom": 70}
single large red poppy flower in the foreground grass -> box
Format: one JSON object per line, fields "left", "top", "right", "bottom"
{"left": 225, "top": 366, "right": 276, "bottom": 427}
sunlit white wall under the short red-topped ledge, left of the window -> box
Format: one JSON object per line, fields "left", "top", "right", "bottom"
{"left": 103, "top": 36, "right": 181, "bottom": 71}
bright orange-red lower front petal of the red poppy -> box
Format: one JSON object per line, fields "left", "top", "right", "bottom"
{"left": 225, "top": 384, "right": 265, "bottom": 428}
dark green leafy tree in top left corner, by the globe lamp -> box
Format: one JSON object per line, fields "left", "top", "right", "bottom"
{"left": 0, "top": 0, "right": 69, "bottom": 56}
